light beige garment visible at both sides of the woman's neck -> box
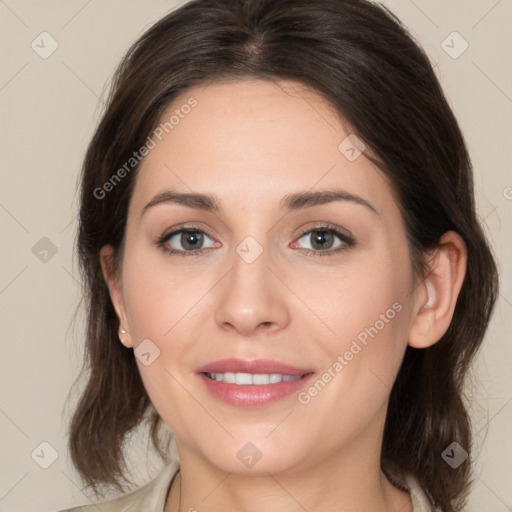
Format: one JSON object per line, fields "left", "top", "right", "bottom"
{"left": 60, "top": 460, "right": 434, "bottom": 512}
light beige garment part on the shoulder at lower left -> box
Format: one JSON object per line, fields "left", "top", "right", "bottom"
{"left": 58, "top": 461, "right": 179, "bottom": 512}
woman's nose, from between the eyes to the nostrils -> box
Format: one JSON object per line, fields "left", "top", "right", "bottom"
{"left": 215, "top": 239, "right": 290, "bottom": 337}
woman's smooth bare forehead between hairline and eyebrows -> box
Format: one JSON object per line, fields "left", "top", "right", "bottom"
{"left": 132, "top": 80, "right": 392, "bottom": 219}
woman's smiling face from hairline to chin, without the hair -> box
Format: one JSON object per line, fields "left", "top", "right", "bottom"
{"left": 104, "top": 81, "right": 420, "bottom": 473}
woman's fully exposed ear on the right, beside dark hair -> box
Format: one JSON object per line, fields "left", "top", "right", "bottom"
{"left": 409, "top": 231, "right": 467, "bottom": 348}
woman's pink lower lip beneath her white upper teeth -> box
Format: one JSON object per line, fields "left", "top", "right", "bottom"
{"left": 199, "top": 373, "right": 313, "bottom": 407}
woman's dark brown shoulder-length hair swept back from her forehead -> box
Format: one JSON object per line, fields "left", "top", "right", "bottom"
{"left": 69, "top": 0, "right": 498, "bottom": 512}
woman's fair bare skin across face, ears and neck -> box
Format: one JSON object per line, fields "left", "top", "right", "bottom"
{"left": 101, "top": 80, "right": 466, "bottom": 512}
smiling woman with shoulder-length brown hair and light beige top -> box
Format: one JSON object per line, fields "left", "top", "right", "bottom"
{"left": 58, "top": 0, "right": 497, "bottom": 512}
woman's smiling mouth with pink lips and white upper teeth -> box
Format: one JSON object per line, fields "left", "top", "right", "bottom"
{"left": 198, "top": 359, "right": 314, "bottom": 408}
